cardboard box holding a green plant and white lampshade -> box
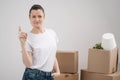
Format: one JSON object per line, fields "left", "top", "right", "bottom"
{"left": 88, "top": 48, "right": 118, "bottom": 73}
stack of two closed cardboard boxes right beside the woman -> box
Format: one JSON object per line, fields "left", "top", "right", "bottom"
{"left": 54, "top": 51, "right": 79, "bottom": 80}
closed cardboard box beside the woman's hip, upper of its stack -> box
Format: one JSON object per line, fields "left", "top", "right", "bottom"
{"left": 56, "top": 51, "right": 78, "bottom": 73}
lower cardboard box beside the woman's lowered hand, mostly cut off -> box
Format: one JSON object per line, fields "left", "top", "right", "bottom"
{"left": 54, "top": 73, "right": 79, "bottom": 80}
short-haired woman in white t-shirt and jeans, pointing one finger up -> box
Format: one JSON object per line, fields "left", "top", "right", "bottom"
{"left": 19, "top": 4, "right": 60, "bottom": 80}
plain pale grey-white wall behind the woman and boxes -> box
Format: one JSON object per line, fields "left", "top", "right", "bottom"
{"left": 0, "top": 0, "right": 120, "bottom": 80}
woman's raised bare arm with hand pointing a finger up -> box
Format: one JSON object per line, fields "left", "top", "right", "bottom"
{"left": 19, "top": 27, "right": 32, "bottom": 68}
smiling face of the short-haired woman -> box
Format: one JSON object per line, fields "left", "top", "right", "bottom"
{"left": 29, "top": 9, "right": 45, "bottom": 28}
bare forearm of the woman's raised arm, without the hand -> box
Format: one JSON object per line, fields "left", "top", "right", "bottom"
{"left": 21, "top": 45, "right": 32, "bottom": 67}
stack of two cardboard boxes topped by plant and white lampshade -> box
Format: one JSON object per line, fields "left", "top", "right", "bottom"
{"left": 81, "top": 48, "right": 120, "bottom": 80}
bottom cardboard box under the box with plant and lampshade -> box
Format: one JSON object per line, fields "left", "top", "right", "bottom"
{"left": 81, "top": 70, "right": 120, "bottom": 80}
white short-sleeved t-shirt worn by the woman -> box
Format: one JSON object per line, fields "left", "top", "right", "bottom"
{"left": 26, "top": 28, "right": 58, "bottom": 72}
